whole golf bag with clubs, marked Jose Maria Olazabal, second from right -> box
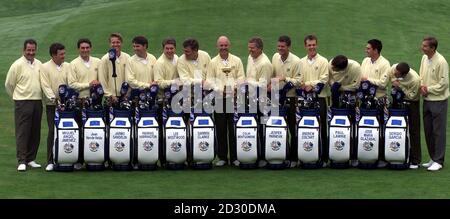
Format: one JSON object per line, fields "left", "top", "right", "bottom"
{"left": 355, "top": 81, "right": 381, "bottom": 168}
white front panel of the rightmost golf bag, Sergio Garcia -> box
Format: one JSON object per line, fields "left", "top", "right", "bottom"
{"left": 384, "top": 116, "right": 409, "bottom": 164}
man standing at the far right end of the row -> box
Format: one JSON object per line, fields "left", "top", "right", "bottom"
{"left": 419, "top": 37, "right": 450, "bottom": 171}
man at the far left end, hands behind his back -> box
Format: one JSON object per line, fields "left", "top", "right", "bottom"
{"left": 5, "top": 39, "right": 42, "bottom": 171}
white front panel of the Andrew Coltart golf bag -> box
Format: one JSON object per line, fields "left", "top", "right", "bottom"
{"left": 297, "top": 116, "right": 320, "bottom": 163}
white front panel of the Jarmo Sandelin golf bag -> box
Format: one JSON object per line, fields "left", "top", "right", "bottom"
{"left": 109, "top": 117, "right": 132, "bottom": 164}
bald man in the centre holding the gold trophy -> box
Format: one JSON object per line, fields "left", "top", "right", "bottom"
{"left": 207, "top": 36, "right": 245, "bottom": 166}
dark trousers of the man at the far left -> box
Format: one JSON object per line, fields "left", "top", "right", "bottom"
{"left": 14, "top": 100, "right": 42, "bottom": 164}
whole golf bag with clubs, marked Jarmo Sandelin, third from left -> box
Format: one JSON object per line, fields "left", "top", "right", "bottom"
{"left": 108, "top": 82, "right": 134, "bottom": 170}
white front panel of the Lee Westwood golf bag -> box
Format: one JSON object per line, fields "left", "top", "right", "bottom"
{"left": 165, "top": 117, "right": 187, "bottom": 164}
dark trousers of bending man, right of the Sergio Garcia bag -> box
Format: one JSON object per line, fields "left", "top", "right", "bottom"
{"left": 408, "top": 101, "right": 422, "bottom": 165}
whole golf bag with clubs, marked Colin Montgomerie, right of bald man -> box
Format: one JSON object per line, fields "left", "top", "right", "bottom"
{"left": 234, "top": 83, "right": 260, "bottom": 169}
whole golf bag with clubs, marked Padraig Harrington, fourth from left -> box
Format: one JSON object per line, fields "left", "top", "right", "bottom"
{"left": 134, "top": 85, "right": 162, "bottom": 170}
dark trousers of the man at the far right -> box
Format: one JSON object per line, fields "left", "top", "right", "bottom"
{"left": 423, "top": 100, "right": 448, "bottom": 165}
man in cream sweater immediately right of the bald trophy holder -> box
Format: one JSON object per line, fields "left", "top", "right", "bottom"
{"left": 247, "top": 37, "right": 274, "bottom": 167}
